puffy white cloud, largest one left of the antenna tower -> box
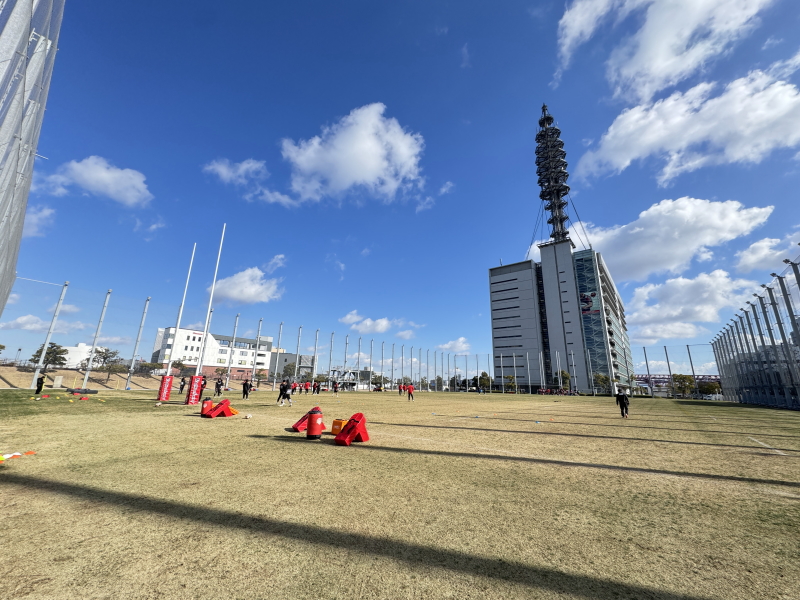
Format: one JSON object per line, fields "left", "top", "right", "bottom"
{"left": 282, "top": 102, "right": 425, "bottom": 202}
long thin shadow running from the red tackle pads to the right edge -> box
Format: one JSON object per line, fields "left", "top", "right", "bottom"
{"left": 264, "top": 435, "right": 800, "bottom": 488}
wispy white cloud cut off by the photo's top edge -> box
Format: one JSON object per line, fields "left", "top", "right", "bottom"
{"left": 556, "top": 0, "right": 773, "bottom": 101}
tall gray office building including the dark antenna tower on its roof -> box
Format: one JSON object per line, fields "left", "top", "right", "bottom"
{"left": 489, "top": 106, "right": 633, "bottom": 393}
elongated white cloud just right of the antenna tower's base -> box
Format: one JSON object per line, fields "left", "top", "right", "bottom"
{"left": 529, "top": 197, "right": 773, "bottom": 282}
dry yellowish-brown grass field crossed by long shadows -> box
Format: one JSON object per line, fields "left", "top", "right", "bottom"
{"left": 0, "top": 391, "right": 800, "bottom": 600}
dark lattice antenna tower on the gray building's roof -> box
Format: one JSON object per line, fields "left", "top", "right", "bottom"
{"left": 536, "top": 104, "right": 569, "bottom": 242}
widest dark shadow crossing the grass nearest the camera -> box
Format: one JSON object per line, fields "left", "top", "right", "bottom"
{"left": 0, "top": 473, "right": 712, "bottom": 600}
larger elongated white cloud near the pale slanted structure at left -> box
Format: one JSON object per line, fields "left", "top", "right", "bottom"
{"left": 36, "top": 156, "right": 153, "bottom": 208}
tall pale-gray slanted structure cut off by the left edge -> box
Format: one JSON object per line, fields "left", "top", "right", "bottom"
{"left": 0, "top": 0, "right": 64, "bottom": 314}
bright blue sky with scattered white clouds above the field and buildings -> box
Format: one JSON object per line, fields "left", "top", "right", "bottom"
{"left": 0, "top": 0, "right": 800, "bottom": 370}
